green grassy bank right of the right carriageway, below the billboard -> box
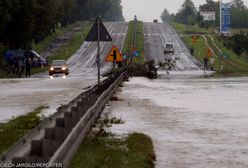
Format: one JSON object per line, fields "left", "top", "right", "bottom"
{"left": 172, "top": 23, "right": 248, "bottom": 76}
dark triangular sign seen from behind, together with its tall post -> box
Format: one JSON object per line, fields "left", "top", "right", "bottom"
{"left": 85, "top": 17, "right": 112, "bottom": 84}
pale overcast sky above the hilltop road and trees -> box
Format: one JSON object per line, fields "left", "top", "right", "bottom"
{"left": 122, "top": 0, "right": 248, "bottom": 22}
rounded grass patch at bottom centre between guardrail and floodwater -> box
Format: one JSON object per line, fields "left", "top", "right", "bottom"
{"left": 69, "top": 133, "right": 155, "bottom": 168}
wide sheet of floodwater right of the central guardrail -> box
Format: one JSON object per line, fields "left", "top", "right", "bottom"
{"left": 110, "top": 72, "right": 248, "bottom": 168}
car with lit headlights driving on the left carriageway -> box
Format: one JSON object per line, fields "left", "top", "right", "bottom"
{"left": 49, "top": 60, "right": 69, "bottom": 76}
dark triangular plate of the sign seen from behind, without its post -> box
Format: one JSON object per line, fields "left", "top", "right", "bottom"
{"left": 85, "top": 22, "right": 112, "bottom": 41}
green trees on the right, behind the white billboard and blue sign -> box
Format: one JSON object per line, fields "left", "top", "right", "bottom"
{"left": 161, "top": 0, "right": 248, "bottom": 28}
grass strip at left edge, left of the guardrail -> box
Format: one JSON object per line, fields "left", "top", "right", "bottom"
{"left": 0, "top": 106, "right": 48, "bottom": 154}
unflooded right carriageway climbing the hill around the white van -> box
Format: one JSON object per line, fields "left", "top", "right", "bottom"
{"left": 144, "top": 23, "right": 202, "bottom": 71}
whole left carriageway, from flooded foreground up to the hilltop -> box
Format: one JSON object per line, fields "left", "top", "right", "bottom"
{"left": 0, "top": 23, "right": 128, "bottom": 123}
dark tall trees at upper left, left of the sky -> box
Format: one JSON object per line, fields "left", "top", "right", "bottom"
{"left": 0, "top": 0, "right": 124, "bottom": 49}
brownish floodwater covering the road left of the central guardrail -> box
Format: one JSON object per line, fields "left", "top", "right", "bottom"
{"left": 0, "top": 74, "right": 96, "bottom": 123}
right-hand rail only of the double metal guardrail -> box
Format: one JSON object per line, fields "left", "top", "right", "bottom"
{"left": 49, "top": 73, "right": 125, "bottom": 167}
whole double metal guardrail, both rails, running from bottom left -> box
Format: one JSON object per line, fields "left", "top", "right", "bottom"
{"left": 0, "top": 72, "right": 126, "bottom": 167}
